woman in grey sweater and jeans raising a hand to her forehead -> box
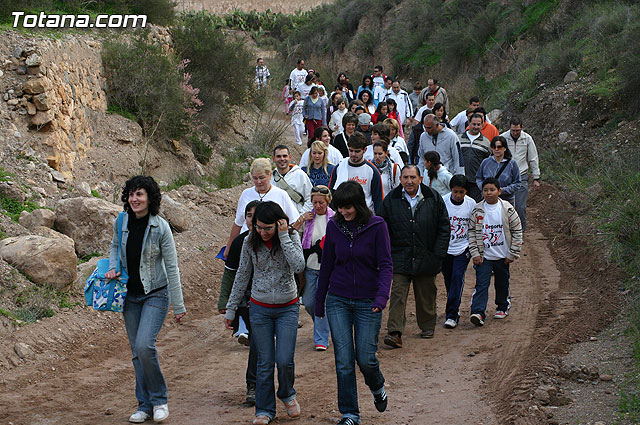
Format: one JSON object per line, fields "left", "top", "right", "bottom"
{"left": 224, "top": 201, "right": 305, "bottom": 425}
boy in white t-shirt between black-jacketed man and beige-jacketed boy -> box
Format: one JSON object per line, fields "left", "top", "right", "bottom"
{"left": 442, "top": 174, "right": 476, "bottom": 329}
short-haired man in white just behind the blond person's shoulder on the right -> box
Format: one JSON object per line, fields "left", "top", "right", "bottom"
{"left": 271, "top": 145, "right": 313, "bottom": 214}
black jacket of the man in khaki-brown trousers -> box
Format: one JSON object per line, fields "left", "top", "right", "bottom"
{"left": 380, "top": 184, "right": 451, "bottom": 276}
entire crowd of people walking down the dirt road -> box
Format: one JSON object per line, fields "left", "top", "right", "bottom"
{"left": 109, "top": 58, "right": 540, "bottom": 425}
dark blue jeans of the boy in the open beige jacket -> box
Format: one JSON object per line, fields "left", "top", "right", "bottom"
{"left": 471, "top": 258, "right": 511, "bottom": 319}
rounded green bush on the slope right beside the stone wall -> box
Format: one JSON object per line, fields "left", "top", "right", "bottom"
{"left": 102, "top": 35, "right": 190, "bottom": 138}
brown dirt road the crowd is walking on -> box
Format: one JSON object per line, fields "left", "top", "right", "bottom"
{"left": 0, "top": 206, "right": 559, "bottom": 425}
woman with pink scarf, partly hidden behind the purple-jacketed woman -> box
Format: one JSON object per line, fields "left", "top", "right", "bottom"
{"left": 293, "top": 185, "right": 335, "bottom": 351}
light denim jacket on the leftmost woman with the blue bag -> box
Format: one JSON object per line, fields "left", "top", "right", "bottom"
{"left": 109, "top": 213, "right": 187, "bottom": 314}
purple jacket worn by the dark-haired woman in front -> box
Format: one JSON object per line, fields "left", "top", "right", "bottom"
{"left": 315, "top": 215, "right": 393, "bottom": 317}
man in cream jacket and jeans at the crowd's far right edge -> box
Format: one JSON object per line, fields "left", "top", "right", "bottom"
{"left": 501, "top": 117, "right": 540, "bottom": 231}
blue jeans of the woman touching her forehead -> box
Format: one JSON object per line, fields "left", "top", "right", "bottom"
{"left": 249, "top": 304, "right": 298, "bottom": 419}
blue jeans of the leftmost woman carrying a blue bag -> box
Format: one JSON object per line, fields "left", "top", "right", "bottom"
{"left": 122, "top": 288, "right": 169, "bottom": 414}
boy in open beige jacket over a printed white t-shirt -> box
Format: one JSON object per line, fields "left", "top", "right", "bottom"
{"left": 469, "top": 177, "right": 522, "bottom": 326}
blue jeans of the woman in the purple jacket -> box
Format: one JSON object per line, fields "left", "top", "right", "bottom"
{"left": 326, "top": 293, "right": 384, "bottom": 422}
